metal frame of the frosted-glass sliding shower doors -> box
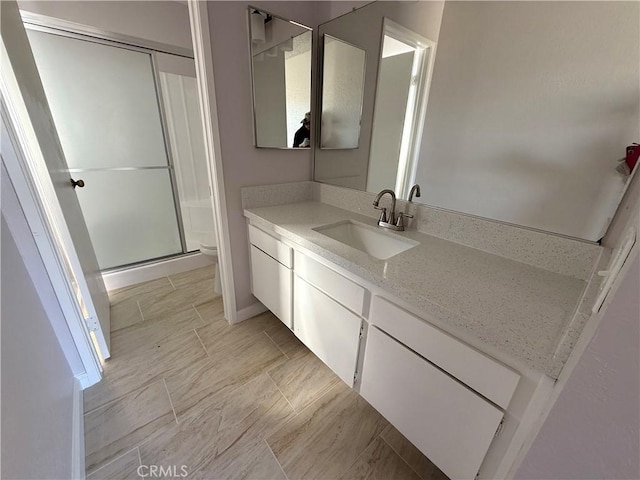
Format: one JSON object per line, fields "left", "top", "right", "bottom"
{"left": 20, "top": 11, "right": 197, "bottom": 273}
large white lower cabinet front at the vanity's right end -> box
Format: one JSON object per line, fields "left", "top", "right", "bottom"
{"left": 360, "top": 327, "right": 503, "bottom": 479}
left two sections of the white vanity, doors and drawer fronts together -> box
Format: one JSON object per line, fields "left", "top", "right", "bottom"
{"left": 248, "top": 225, "right": 365, "bottom": 386}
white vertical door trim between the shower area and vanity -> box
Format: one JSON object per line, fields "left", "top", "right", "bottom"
{"left": 188, "top": 0, "right": 241, "bottom": 323}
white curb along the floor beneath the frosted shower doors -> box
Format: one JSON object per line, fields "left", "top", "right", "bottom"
{"left": 102, "top": 253, "right": 215, "bottom": 290}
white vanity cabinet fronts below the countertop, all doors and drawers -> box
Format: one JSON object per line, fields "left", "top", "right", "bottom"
{"left": 248, "top": 225, "right": 549, "bottom": 479}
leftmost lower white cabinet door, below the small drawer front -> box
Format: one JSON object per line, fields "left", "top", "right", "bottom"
{"left": 251, "top": 245, "right": 293, "bottom": 328}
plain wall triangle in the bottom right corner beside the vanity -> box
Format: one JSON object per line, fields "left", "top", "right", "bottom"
{"left": 516, "top": 253, "right": 640, "bottom": 480}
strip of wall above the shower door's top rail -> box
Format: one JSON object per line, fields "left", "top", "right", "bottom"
{"left": 18, "top": 0, "right": 193, "bottom": 49}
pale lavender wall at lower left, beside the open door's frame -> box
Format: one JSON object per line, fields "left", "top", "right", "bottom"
{"left": 0, "top": 192, "right": 81, "bottom": 479}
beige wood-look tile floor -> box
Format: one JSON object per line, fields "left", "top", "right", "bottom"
{"left": 84, "top": 267, "right": 446, "bottom": 480}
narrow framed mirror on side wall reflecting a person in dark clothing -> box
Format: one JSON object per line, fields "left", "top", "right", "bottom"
{"left": 249, "top": 8, "right": 311, "bottom": 148}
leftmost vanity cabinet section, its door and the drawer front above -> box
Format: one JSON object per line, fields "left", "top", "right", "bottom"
{"left": 249, "top": 225, "right": 293, "bottom": 329}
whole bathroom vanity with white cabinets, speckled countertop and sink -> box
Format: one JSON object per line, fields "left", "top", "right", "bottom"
{"left": 245, "top": 182, "right": 600, "bottom": 478}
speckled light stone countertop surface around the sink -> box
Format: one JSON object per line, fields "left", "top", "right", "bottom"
{"left": 245, "top": 202, "right": 586, "bottom": 378}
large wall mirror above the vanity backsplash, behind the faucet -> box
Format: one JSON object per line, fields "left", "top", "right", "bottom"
{"left": 314, "top": 1, "right": 640, "bottom": 241}
